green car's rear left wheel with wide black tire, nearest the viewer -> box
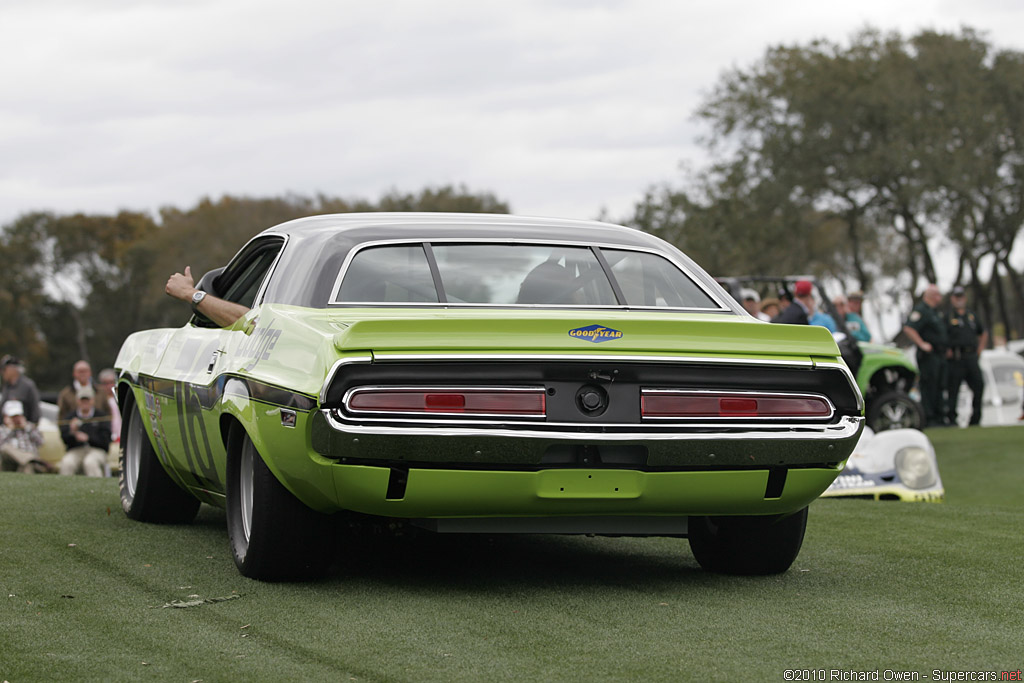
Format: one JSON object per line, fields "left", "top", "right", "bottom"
{"left": 226, "top": 425, "right": 332, "bottom": 581}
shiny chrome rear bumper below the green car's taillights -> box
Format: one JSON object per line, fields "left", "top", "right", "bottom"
{"left": 311, "top": 411, "right": 863, "bottom": 469}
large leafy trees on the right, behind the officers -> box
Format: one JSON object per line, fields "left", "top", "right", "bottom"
{"left": 627, "top": 28, "right": 1024, "bottom": 337}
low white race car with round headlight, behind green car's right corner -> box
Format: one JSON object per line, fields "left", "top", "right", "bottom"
{"left": 821, "top": 428, "right": 945, "bottom": 503}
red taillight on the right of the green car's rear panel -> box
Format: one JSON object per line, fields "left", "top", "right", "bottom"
{"left": 640, "top": 389, "right": 834, "bottom": 419}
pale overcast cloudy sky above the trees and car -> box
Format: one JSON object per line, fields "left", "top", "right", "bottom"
{"left": 0, "top": 0, "right": 1024, "bottom": 224}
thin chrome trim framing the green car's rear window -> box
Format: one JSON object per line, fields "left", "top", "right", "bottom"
{"left": 327, "top": 237, "right": 734, "bottom": 313}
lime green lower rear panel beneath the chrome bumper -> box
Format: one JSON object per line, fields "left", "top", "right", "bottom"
{"left": 331, "top": 465, "right": 839, "bottom": 520}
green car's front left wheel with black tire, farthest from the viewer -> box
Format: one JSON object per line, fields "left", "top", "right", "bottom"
{"left": 118, "top": 393, "right": 200, "bottom": 524}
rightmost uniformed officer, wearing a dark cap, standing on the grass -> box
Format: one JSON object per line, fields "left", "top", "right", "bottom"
{"left": 946, "top": 286, "right": 988, "bottom": 425}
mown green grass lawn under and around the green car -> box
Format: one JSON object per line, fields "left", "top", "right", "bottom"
{"left": 0, "top": 427, "right": 1024, "bottom": 683}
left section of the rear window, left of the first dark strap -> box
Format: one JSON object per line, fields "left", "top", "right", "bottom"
{"left": 336, "top": 245, "right": 437, "bottom": 303}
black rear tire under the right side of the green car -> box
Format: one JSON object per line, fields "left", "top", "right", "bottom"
{"left": 687, "top": 508, "right": 807, "bottom": 575}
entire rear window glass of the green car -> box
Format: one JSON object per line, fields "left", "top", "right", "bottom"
{"left": 332, "top": 243, "right": 721, "bottom": 309}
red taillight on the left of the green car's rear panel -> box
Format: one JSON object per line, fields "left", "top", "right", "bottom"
{"left": 345, "top": 387, "right": 547, "bottom": 417}
